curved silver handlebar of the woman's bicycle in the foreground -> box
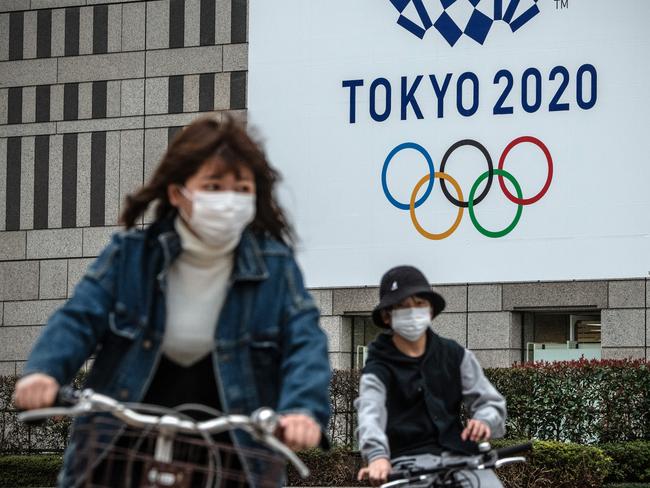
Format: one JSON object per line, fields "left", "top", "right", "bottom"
{"left": 18, "top": 386, "right": 309, "bottom": 478}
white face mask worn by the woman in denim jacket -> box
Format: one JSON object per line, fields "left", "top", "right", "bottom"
{"left": 181, "top": 188, "right": 255, "bottom": 247}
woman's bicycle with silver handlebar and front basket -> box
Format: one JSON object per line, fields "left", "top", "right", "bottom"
{"left": 19, "top": 387, "right": 309, "bottom": 488}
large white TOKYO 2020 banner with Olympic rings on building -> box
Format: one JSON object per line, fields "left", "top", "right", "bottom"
{"left": 249, "top": 0, "right": 650, "bottom": 287}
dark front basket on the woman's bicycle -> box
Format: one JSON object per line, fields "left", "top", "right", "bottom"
{"left": 66, "top": 415, "right": 285, "bottom": 488}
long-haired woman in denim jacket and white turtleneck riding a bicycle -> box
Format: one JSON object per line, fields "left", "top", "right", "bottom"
{"left": 15, "top": 118, "right": 330, "bottom": 486}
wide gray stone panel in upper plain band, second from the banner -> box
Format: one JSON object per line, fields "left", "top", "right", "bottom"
{"left": 145, "top": 46, "right": 222, "bottom": 77}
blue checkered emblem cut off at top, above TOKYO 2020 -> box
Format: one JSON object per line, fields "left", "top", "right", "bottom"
{"left": 390, "top": 0, "right": 539, "bottom": 46}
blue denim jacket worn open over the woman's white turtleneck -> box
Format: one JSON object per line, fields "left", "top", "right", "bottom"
{"left": 24, "top": 218, "right": 330, "bottom": 486}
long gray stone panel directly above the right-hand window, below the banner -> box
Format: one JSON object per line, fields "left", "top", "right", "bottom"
{"left": 503, "top": 281, "right": 607, "bottom": 310}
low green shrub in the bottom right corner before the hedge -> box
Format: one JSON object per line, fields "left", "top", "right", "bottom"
{"left": 598, "top": 441, "right": 650, "bottom": 482}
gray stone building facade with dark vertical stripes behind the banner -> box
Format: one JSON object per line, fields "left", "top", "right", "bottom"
{"left": 0, "top": 0, "right": 650, "bottom": 374}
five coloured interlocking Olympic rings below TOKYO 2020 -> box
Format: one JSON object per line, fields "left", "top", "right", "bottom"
{"left": 381, "top": 136, "right": 553, "bottom": 241}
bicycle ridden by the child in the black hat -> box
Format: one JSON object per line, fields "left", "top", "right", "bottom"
{"left": 381, "top": 442, "right": 532, "bottom": 488}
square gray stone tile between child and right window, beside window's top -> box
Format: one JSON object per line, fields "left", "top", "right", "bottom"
{"left": 467, "top": 312, "right": 519, "bottom": 349}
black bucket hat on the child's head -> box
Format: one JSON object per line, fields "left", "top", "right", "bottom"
{"left": 372, "top": 266, "right": 445, "bottom": 329}
